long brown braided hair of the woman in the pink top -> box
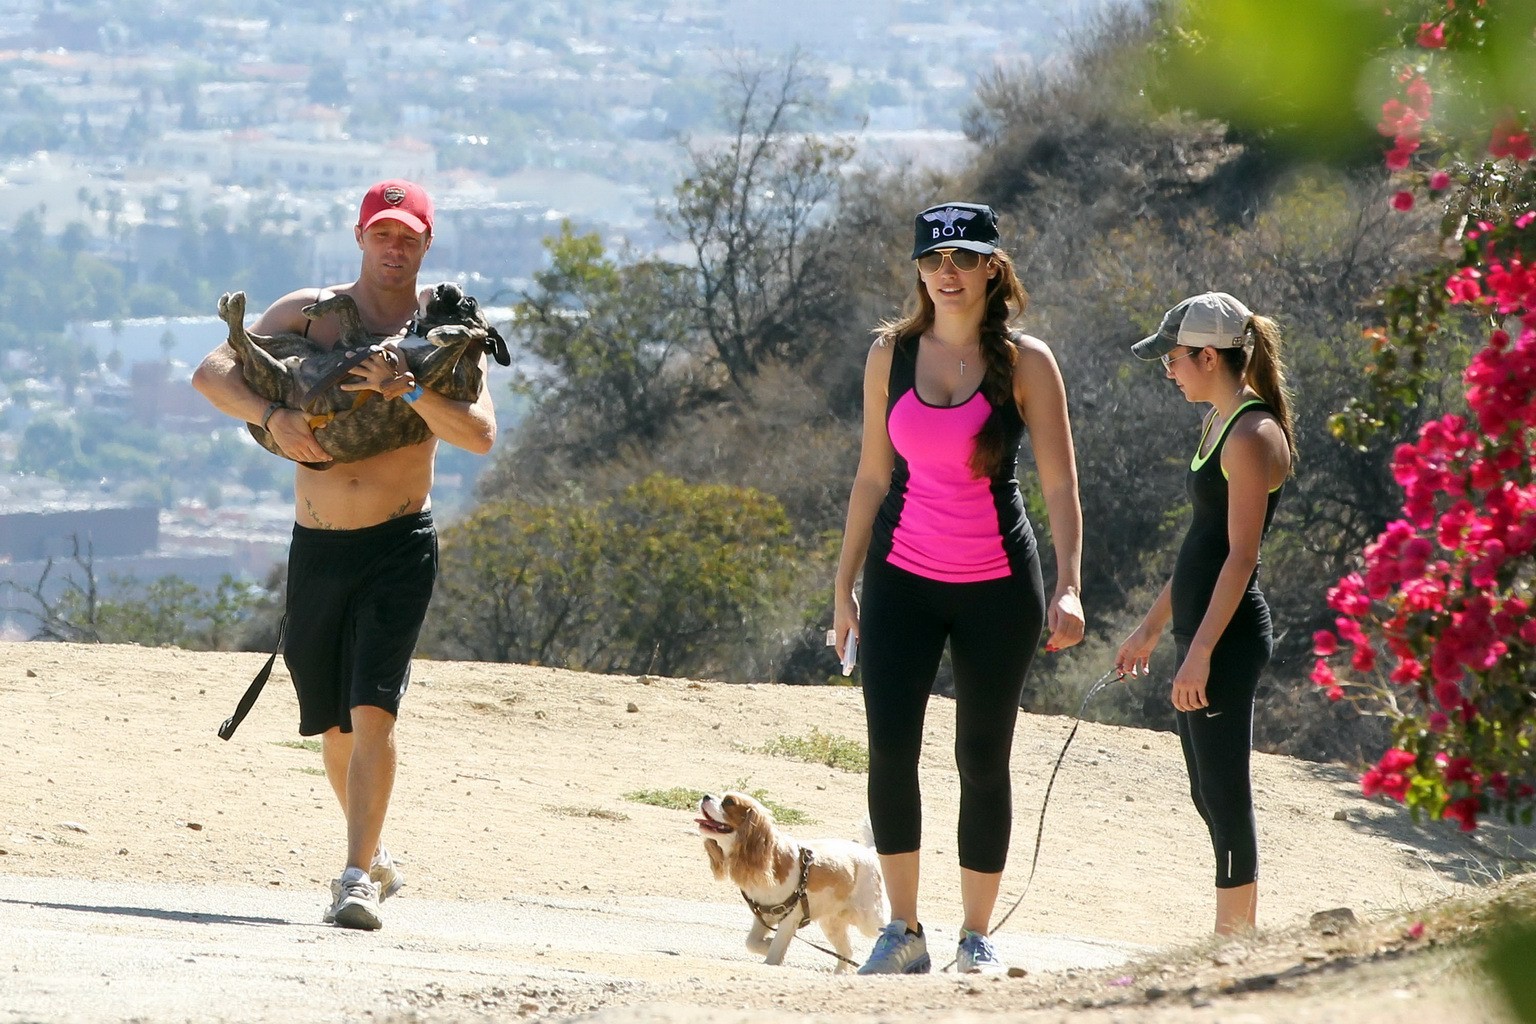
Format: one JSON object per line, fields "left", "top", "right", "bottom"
{"left": 874, "top": 249, "right": 1029, "bottom": 477}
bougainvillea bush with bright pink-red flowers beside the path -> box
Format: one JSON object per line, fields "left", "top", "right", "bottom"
{"left": 1312, "top": 0, "right": 1536, "bottom": 831}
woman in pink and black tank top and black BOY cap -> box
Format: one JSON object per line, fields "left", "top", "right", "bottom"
{"left": 833, "top": 203, "right": 1083, "bottom": 975}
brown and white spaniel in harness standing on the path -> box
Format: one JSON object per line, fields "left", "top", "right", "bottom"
{"left": 697, "top": 792, "right": 885, "bottom": 973}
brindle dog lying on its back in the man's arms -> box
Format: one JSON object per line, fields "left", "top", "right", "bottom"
{"left": 218, "top": 282, "right": 511, "bottom": 470}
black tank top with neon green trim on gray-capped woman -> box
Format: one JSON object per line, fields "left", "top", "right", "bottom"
{"left": 1172, "top": 399, "right": 1286, "bottom": 640}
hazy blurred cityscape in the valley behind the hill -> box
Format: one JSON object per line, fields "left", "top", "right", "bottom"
{"left": 0, "top": 0, "right": 1130, "bottom": 639}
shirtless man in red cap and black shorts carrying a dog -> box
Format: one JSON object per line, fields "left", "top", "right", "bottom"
{"left": 192, "top": 180, "right": 496, "bottom": 929}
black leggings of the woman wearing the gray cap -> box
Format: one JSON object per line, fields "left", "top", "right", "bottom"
{"left": 1174, "top": 623, "right": 1272, "bottom": 889}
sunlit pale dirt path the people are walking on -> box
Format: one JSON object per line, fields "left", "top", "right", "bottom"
{"left": 0, "top": 645, "right": 1529, "bottom": 1024}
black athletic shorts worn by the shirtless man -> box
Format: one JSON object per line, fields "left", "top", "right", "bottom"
{"left": 283, "top": 510, "right": 438, "bottom": 735}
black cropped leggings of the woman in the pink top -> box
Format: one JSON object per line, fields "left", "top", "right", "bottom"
{"left": 859, "top": 556, "right": 1046, "bottom": 874}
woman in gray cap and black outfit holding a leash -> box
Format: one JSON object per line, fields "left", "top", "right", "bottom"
{"left": 1115, "top": 292, "right": 1296, "bottom": 935}
